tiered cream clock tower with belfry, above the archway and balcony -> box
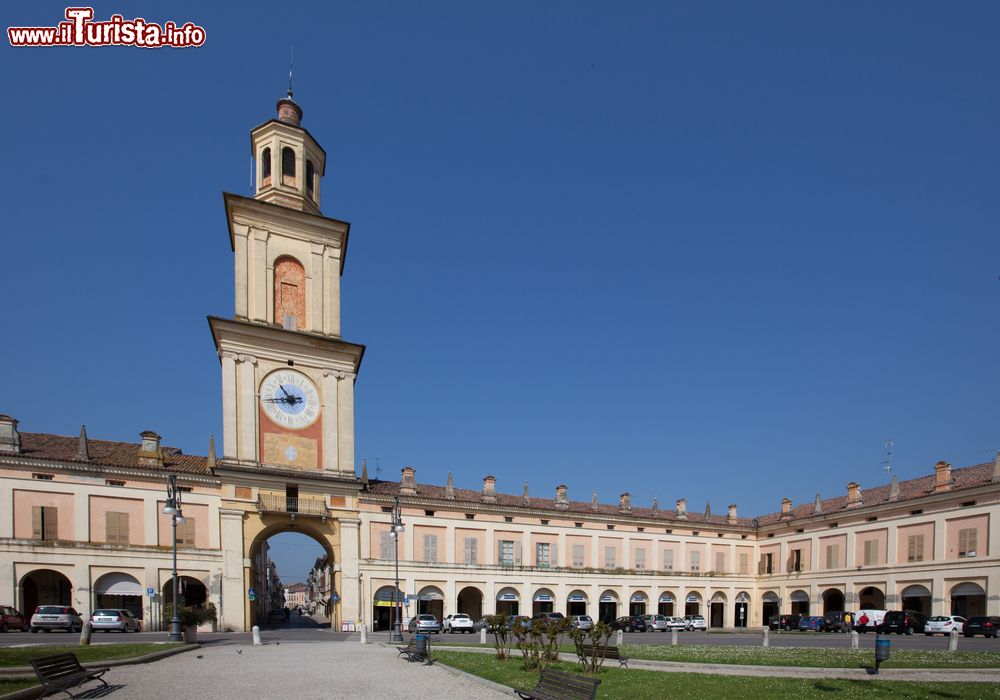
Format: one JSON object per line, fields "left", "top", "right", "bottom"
{"left": 209, "top": 94, "right": 364, "bottom": 479}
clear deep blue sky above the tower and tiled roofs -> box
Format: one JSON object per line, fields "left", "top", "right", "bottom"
{"left": 0, "top": 1, "right": 1000, "bottom": 575}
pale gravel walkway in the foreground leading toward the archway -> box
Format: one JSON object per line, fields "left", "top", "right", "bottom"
{"left": 94, "top": 642, "right": 506, "bottom": 700}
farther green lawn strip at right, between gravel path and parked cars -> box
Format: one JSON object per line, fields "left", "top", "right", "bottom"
{"left": 438, "top": 644, "right": 1000, "bottom": 668}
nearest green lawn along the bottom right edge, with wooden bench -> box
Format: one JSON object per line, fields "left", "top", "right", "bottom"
{"left": 434, "top": 651, "right": 1000, "bottom": 700}
